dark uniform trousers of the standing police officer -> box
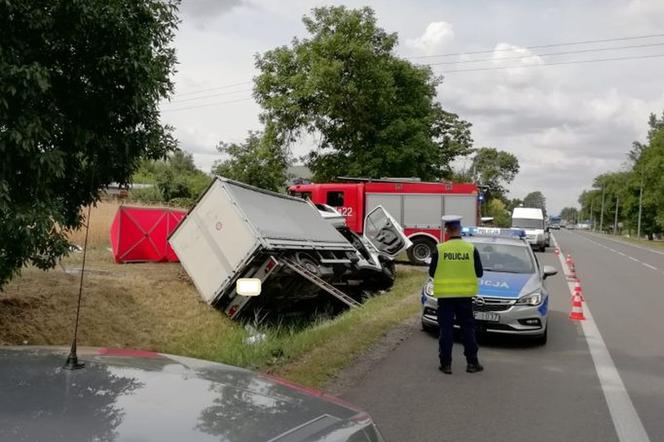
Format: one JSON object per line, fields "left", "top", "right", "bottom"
{"left": 438, "top": 297, "right": 478, "bottom": 365}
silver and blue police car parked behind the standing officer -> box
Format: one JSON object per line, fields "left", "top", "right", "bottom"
{"left": 422, "top": 227, "right": 558, "bottom": 344}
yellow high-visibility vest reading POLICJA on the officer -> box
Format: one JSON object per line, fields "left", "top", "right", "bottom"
{"left": 433, "top": 239, "right": 477, "bottom": 298}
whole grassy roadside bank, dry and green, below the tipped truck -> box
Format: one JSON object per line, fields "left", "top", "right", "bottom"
{"left": 0, "top": 203, "right": 424, "bottom": 386}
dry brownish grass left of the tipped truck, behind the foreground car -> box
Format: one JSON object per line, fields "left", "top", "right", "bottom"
{"left": 0, "top": 250, "right": 237, "bottom": 352}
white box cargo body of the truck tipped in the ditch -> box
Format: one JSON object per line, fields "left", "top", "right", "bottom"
{"left": 169, "top": 177, "right": 356, "bottom": 304}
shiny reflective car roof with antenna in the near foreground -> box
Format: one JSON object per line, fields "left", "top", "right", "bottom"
{"left": 0, "top": 347, "right": 383, "bottom": 442}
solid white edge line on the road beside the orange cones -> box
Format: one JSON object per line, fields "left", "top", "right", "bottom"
{"left": 551, "top": 235, "right": 650, "bottom": 442}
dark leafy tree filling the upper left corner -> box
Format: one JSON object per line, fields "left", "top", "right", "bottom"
{"left": 0, "top": 0, "right": 177, "bottom": 287}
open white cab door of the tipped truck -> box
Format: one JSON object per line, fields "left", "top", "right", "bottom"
{"left": 364, "top": 206, "right": 413, "bottom": 258}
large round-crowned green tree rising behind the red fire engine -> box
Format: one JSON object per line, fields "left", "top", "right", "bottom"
{"left": 254, "top": 6, "right": 472, "bottom": 181}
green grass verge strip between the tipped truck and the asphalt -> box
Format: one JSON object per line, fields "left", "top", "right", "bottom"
{"left": 167, "top": 270, "right": 424, "bottom": 387}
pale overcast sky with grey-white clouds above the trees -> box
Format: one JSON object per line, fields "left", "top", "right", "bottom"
{"left": 162, "top": 0, "right": 664, "bottom": 213}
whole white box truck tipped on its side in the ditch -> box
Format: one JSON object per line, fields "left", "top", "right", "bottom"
{"left": 169, "top": 177, "right": 410, "bottom": 318}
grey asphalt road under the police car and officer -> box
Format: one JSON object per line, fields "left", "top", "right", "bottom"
{"left": 343, "top": 230, "right": 664, "bottom": 441}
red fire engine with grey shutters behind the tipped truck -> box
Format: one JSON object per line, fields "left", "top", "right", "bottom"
{"left": 288, "top": 177, "right": 479, "bottom": 265}
